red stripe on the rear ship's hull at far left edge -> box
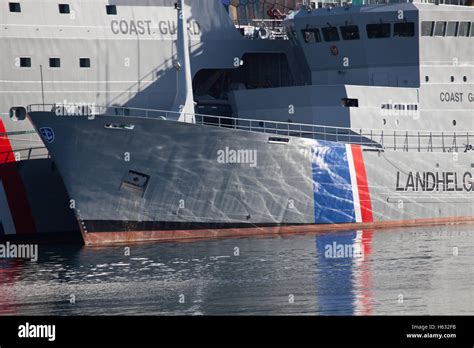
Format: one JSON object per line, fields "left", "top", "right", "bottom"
{"left": 0, "top": 119, "right": 36, "bottom": 234}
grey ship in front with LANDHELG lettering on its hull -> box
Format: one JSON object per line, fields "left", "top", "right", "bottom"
{"left": 28, "top": 2, "right": 474, "bottom": 244}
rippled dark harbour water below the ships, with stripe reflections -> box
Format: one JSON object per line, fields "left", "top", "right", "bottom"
{"left": 0, "top": 226, "right": 474, "bottom": 315}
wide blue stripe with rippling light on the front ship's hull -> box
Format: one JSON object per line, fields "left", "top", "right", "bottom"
{"left": 312, "top": 142, "right": 356, "bottom": 224}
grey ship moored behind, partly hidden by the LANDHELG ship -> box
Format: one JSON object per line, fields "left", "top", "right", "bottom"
{"left": 0, "top": 0, "right": 296, "bottom": 242}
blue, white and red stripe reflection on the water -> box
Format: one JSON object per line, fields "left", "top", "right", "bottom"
{"left": 316, "top": 230, "right": 372, "bottom": 315}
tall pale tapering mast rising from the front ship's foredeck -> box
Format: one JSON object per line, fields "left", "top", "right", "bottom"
{"left": 172, "top": 0, "right": 195, "bottom": 123}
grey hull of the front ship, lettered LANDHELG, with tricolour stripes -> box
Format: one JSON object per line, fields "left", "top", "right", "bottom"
{"left": 30, "top": 112, "right": 474, "bottom": 244}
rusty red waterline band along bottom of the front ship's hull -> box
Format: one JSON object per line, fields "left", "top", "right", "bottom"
{"left": 82, "top": 216, "right": 474, "bottom": 246}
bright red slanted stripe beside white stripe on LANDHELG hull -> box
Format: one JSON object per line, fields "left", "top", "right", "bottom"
{"left": 351, "top": 145, "right": 374, "bottom": 222}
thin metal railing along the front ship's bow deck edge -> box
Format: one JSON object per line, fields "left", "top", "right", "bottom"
{"left": 27, "top": 104, "right": 474, "bottom": 153}
